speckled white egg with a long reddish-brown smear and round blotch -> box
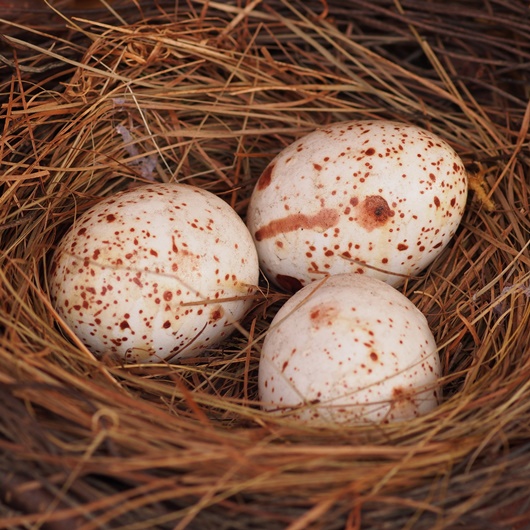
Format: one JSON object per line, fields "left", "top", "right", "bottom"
{"left": 247, "top": 120, "right": 467, "bottom": 292}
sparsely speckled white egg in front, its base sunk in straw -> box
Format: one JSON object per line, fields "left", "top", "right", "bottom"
{"left": 258, "top": 273, "right": 441, "bottom": 424}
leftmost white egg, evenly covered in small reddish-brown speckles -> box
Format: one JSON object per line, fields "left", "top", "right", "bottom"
{"left": 49, "top": 184, "right": 259, "bottom": 363}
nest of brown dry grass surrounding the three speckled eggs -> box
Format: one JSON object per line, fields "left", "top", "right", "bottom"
{"left": 0, "top": 1, "right": 530, "bottom": 530}
